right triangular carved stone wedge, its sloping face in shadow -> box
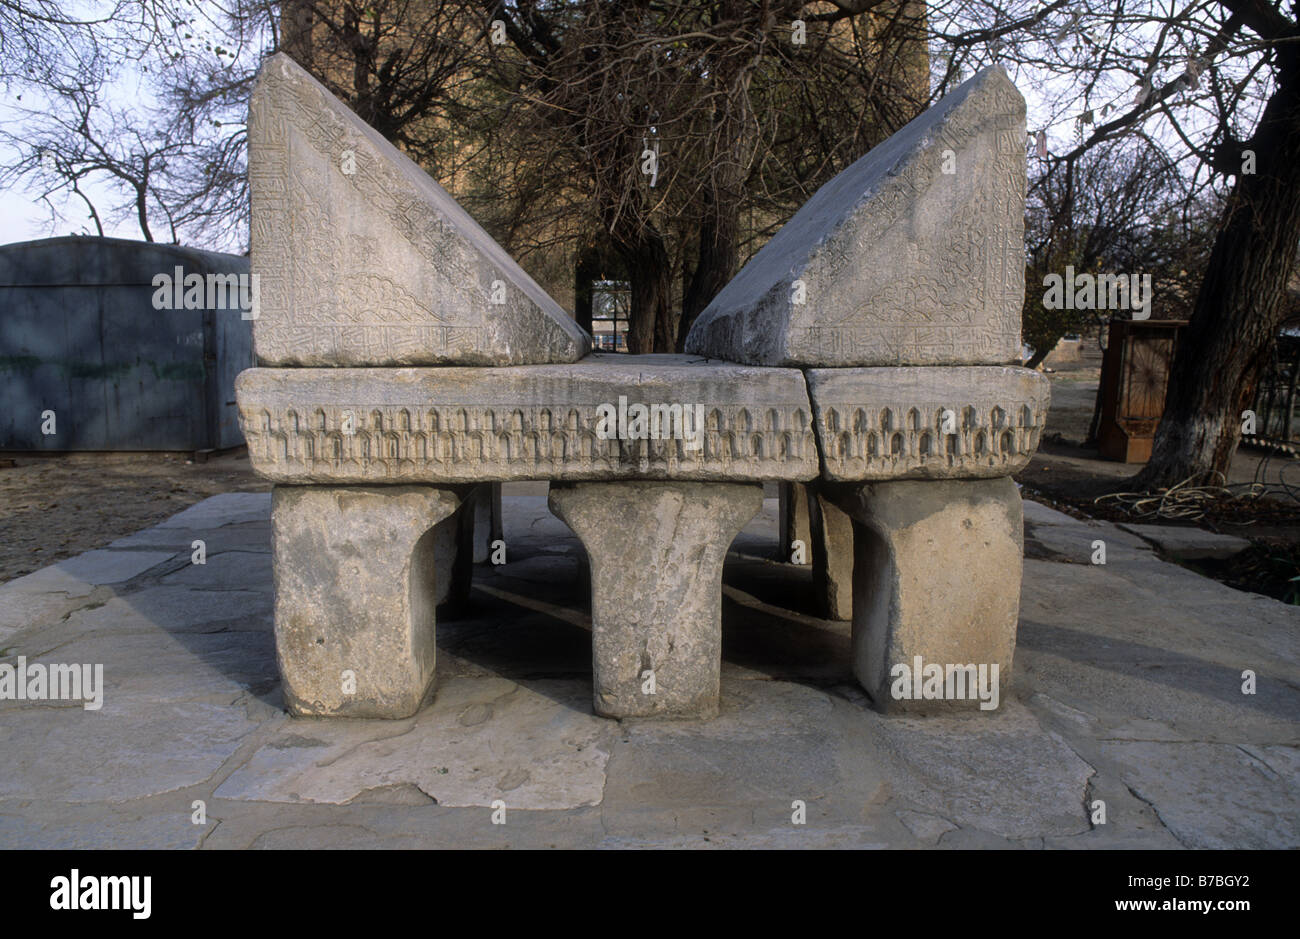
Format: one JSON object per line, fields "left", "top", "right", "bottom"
{"left": 686, "top": 68, "right": 1026, "bottom": 367}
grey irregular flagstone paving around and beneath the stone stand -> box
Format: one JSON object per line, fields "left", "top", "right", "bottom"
{"left": 0, "top": 484, "right": 1300, "bottom": 848}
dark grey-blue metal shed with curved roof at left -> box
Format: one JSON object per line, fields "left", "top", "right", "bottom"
{"left": 0, "top": 235, "right": 254, "bottom": 450}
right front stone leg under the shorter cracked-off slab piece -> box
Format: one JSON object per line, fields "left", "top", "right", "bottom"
{"left": 828, "top": 479, "right": 1024, "bottom": 711}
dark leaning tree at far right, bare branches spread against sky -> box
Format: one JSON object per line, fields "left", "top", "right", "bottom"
{"left": 931, "top": 0, "right": 1300, "bottom": 488}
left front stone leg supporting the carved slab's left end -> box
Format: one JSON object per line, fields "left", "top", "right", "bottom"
{"left": 272, "top": 486, "right": 460, "bottom": 718}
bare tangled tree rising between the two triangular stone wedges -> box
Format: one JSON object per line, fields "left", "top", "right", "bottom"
{"left": 482, "top": 0, "right": 928, "bottom": 351}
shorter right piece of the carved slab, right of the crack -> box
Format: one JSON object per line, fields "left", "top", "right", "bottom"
{"left": 807, "top": 365, "right": 1052, "bottom": 481}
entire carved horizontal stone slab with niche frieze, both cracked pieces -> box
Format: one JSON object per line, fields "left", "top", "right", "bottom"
{"left": 235, "top": 355, "right": 1050, "bottom": 485}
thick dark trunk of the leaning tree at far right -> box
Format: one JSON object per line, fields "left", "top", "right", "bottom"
{"left": 1128, "top": 49, "right": 1300, "bottom": 490}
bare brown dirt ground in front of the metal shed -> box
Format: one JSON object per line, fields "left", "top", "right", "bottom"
{"left": 0, "top": 447, "right": 270, "bottom": 583}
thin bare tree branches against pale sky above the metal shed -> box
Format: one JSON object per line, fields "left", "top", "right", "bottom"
{"left": 0, "top": 0, "right": 269, "bottom": 245}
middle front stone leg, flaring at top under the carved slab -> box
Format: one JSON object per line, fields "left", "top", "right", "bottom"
{"left": 550, "top": 483, "right": 763, "bottom": 718}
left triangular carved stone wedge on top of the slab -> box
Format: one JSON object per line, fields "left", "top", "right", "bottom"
{"left": 248, "top": 55, "right": 592, "bottom": 365}
